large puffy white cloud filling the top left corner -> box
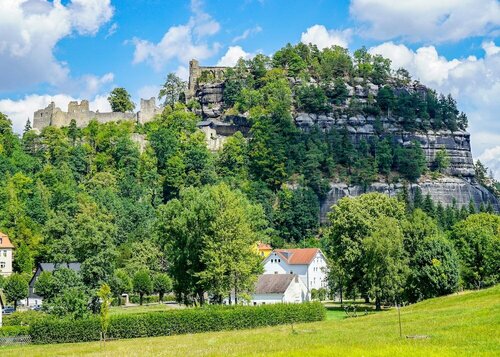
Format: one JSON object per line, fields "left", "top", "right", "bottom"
{"left": 0, "top": 0, "right": 114, "bottom": 92}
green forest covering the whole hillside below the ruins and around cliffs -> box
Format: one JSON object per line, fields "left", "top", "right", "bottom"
{"left": 0, "top": 44, "right": 500, "bottom": 314}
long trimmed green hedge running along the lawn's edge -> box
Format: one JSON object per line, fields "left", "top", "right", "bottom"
{"left": 30, "top": 303, "right": 326, "bottom": 343}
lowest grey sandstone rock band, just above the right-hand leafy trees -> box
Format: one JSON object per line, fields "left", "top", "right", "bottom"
{"left": 320, "top": 176, "right": 500, "bottom": 223}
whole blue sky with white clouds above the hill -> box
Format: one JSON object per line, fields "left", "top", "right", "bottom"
{"left": 0, "top": 0, "right": 500, "bottom": 177}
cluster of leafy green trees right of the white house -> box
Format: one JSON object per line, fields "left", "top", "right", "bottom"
{"left": 322, "top": 193, "right": 500, "bottom": 308}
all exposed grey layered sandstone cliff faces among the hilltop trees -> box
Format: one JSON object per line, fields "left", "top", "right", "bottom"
{"left": 189, "top": 72, "right": 500, "bottom": 213}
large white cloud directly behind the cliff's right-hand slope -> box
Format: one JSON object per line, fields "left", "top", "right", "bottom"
{"left": 370, "top": 42, "right": 500, "bottom": 178}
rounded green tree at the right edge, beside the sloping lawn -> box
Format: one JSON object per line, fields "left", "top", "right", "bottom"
{"left": 450, "top": 213, "right": 500, "bottom": 288}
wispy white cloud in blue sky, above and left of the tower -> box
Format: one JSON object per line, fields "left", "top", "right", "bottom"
{"left": 132, "top": 0, "right": 221, "bottom": 71}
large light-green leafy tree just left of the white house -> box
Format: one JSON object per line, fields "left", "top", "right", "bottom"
{"left": 159, "top": 184, "right": 267, "bottom": 304}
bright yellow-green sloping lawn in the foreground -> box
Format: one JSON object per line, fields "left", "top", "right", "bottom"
{"left": 0, "top": 286, "right": 500, "bottom": 357}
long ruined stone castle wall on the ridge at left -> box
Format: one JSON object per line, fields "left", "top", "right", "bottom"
{"left": 33, "top": 97, "right": 162, "bottom": 131}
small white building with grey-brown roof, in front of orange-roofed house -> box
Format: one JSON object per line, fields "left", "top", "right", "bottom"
{"left": 250, "top": 274, "right": 308, "bottom": 305}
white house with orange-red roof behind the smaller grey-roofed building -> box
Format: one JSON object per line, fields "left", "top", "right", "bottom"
{"left": 264, "top": 248, "right": 328, "bottom": 298}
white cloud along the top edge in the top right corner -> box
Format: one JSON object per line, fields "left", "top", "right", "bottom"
{"left": 350, "top": 0, "right": 500, "bottom": 42}
